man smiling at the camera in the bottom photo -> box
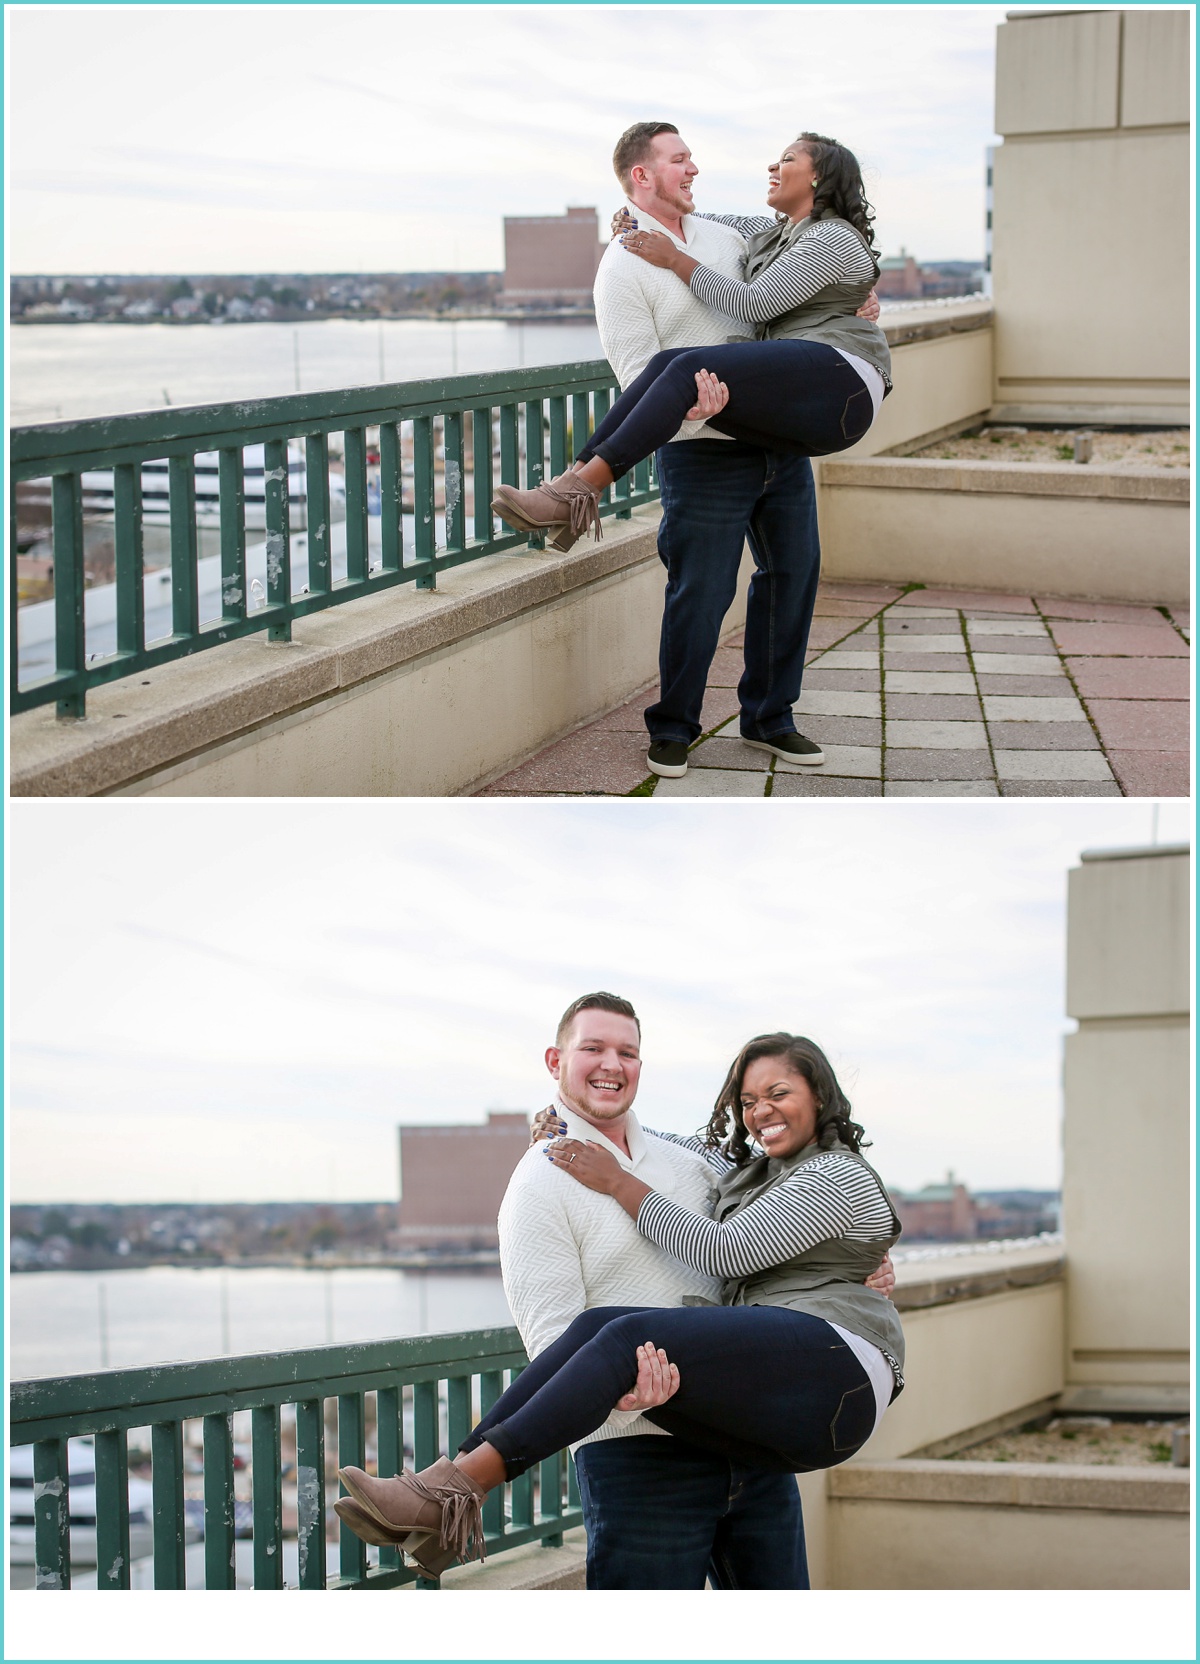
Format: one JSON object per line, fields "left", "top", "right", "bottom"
{"left": 499, "top": 993, "right": 894, "bottom": 1589}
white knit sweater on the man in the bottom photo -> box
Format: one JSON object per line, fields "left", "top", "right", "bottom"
{"left": 499, "top": 1111, "right": 721, "bottom": 1448}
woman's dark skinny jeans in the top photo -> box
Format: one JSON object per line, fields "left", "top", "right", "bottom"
{"left": 579, "top": 341, "right": 874, "bottom": 479}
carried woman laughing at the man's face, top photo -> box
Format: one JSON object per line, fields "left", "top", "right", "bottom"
{"left": 491, "top": 133, "right": 892, "bottom": 549}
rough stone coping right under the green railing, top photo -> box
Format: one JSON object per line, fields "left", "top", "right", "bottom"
{"left": 10, "top": 509, "right": 659, "bottom": 797}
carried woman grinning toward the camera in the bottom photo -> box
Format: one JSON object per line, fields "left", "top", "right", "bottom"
{"left": 335, "top": 1033, "right": 904, "bottom": 1576}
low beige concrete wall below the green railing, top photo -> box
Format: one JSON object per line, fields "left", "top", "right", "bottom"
{"left": 10, "top": 509, "right": 662, "bottom": 797}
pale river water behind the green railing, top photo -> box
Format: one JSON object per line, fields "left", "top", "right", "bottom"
{"left": 8, "top": 318, "right": 604, "bottom": 424}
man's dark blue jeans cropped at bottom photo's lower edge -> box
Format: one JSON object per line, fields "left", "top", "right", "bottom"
{"left": 574, "top": 1436, "right": 809, "bottom": 1589}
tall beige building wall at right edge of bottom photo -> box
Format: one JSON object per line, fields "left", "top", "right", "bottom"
{"left": 1064, "top": 845, "right": 1192, "bottom": 1413}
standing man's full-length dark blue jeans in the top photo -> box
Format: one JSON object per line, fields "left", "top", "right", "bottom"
{"left": 646, "top": 439, "right": 821, "bottom": 745}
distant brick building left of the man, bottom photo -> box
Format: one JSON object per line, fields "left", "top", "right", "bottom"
{"left": 393, "top": 1110, "right": 529, "bottom": 1248}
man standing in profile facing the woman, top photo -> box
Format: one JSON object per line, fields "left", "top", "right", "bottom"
{"left": 594, "top": 121, "right": 879, "bottom": 779}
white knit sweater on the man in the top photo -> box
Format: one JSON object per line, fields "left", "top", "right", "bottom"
{"left": 594, "top": 203, "right": 754, "bottom": 443}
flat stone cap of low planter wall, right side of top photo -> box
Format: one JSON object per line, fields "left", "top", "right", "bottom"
{"left": 821, "top": 456, "right": 1192, "bottom": 503}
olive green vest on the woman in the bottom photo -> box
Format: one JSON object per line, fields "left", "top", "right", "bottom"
{"left": 712, "top": 1143, "right": 904, "bottom": 1391}
